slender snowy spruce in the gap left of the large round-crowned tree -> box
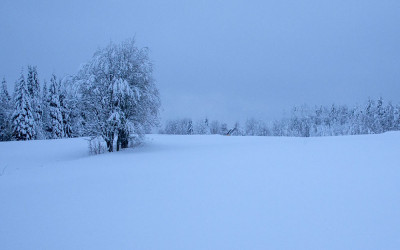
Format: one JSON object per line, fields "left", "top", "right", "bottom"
{"left": 49, "top": 74, "right": 64, "bottom": 139}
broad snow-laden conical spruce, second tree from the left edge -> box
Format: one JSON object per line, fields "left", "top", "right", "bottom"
{"left": 12, "top": 72, "right": 36, "bottom": 140}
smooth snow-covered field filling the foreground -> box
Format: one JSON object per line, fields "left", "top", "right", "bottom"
{"left": 0, "top": 132, "right": 400, "bottom": 250}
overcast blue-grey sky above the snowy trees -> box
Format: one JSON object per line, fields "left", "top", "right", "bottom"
{"left": 0, "top": 0, "right": 400, "bottom": 122}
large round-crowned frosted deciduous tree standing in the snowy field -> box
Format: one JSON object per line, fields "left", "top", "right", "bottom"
{"left": 76, "top": 39, "right": 160, "bottom": 152}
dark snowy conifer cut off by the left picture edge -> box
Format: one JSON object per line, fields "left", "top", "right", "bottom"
{"left": 0, "top": 78, "right": 12, "bottom": 141}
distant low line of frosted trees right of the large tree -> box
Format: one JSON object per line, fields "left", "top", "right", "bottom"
{"left": 160, "top": 98, "right": 400, "bottom": 137}
